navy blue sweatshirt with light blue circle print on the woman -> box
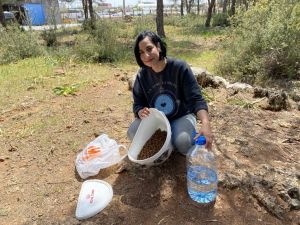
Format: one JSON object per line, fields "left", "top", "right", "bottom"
{"left": 133, "top": 58, "right": 208, "bottom": 120}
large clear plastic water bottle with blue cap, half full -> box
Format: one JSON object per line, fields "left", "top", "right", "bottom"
{"left": 187, "top": 136, "right": 218, "bottom": 204}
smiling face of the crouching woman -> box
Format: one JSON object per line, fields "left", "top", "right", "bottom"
{"left": 139, "top": 37, "right": 161, "bottom": 68}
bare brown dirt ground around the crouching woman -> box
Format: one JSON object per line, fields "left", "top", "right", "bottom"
{"left": 0, "top": 69, "right": 300, "bottom": 225}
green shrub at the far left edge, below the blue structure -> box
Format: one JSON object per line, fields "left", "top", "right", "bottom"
{"left": 0, "top": 26, "right": 44, "bottom": 64}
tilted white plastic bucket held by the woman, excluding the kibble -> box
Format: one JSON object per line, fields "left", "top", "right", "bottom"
{"left": 128, "top": 108, "right": 173, "bottom": 166}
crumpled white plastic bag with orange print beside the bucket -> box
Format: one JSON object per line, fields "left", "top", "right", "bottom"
{"left": 75, "top": 134, "right": 127, "bottom": 179}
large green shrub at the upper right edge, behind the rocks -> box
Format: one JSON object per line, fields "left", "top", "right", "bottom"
{"left": 218, "top": 0, "right": 300, "bottom": 83}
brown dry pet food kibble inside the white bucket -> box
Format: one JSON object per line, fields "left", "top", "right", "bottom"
{"left": 138, "top": 130, "right": 167, "bottom": 160}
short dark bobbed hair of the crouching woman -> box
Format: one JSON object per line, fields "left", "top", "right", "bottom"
{"left": 134, "top": 30, "right": 167, "bottom": 67}
